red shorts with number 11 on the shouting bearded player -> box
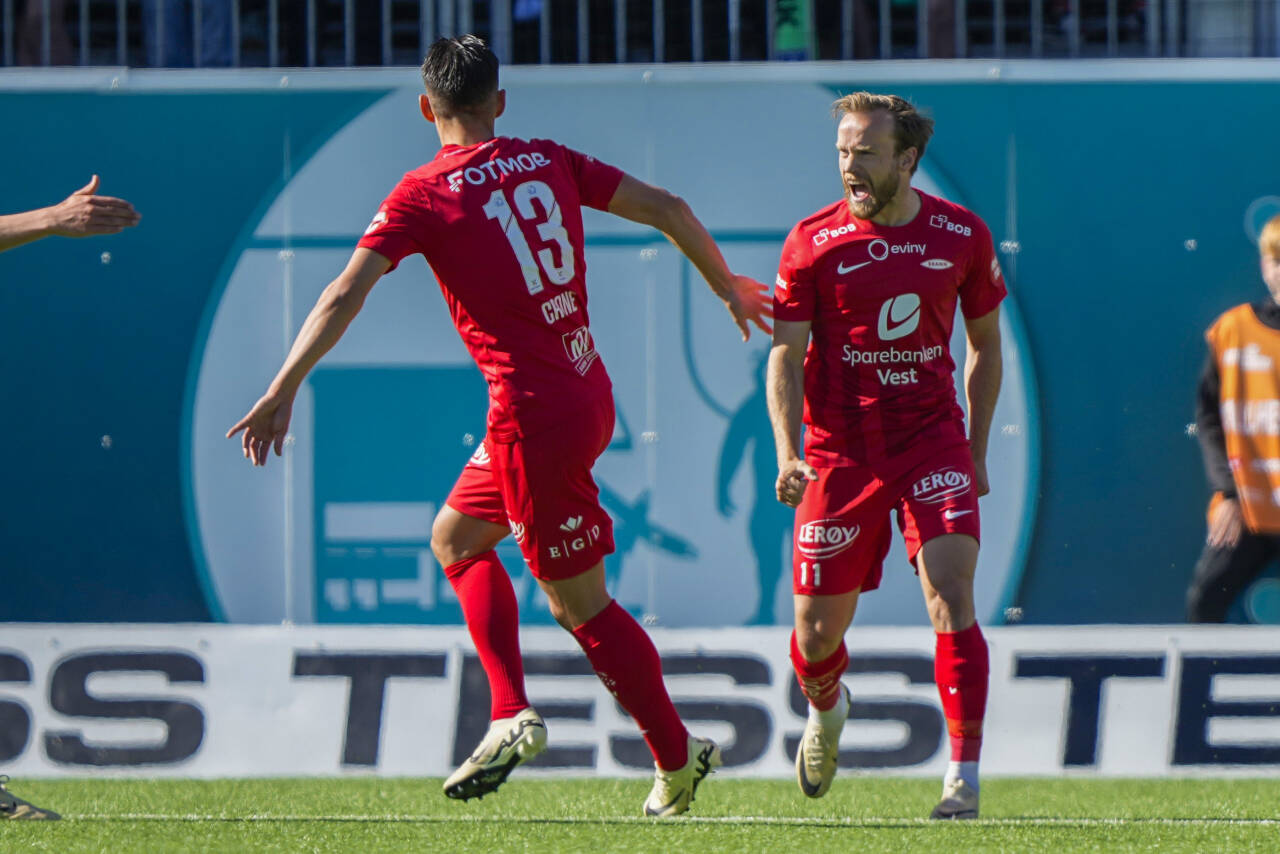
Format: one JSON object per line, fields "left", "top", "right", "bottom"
{"left": 791, "top": 446, "right": 979, "bottom": 595}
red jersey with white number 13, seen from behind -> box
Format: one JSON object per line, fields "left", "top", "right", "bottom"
{"left": 360, "top": 137, "right": 622, "bottom": 442}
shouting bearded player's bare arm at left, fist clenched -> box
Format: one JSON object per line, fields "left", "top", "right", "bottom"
{"left": 764, "top": 320, "right": 818, "bottom": 507}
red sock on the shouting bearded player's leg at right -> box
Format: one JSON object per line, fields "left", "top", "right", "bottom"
{"left": 933, "top": 624, "right": 991, "bottom": 762}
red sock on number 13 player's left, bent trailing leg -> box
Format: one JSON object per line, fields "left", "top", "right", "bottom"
{"left": 444, "top": 549, "right": 529, "bottom": 721}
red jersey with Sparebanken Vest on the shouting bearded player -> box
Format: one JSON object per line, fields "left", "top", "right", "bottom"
{"left": 773, "top": 191, "right": 1006, "bottom": 466}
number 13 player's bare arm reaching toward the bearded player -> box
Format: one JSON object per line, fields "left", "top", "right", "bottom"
{"left": 609, "top": 175, "right": 773, "bottom": 341}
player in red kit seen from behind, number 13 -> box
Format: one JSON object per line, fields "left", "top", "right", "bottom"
{"left": 228, "top": 36, "right": 769, "bottom": 816}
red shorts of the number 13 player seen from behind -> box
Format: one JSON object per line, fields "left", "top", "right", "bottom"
{"left": 445, "top": 398, "right": 613, "bottom": 581}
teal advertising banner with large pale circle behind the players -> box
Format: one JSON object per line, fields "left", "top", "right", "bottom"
{"left": 0, "top": 61, "right": 1280, "bottom": 627}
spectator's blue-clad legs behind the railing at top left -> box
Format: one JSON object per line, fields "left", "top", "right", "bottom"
{"left": 142, "top": 0, "right": 232, "bottom": 68}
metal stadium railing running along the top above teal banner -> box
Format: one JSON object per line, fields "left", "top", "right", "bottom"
{"left": 0, "top": 0, "right": 1280, "bottom": 67}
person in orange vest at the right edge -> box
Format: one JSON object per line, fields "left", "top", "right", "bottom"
{"left": 1187, "top": 215, "right": 1280, "bottom": 622}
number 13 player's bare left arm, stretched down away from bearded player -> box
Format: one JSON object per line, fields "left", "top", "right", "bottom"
{"left": 227, "top": 248, "right": 392, "bottom": 466}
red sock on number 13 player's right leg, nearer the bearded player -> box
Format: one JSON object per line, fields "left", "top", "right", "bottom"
{"left": 573, "top": 602, "right": 689, "bottom": 771}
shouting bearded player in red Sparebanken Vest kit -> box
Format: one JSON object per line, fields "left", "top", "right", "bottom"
{"left": 768, "top": 92, "right": 1005, "bottom": 818}
